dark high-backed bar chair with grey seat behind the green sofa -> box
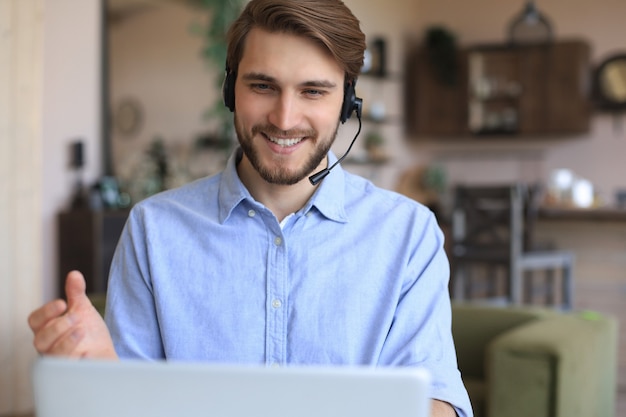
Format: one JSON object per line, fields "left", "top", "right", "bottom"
{"left": 450, "top": 183, "right": 574, "bottom": 309}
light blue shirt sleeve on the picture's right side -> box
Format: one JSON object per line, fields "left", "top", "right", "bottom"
{"left": 381, "top": 213, "right": 473, "bottom": 417}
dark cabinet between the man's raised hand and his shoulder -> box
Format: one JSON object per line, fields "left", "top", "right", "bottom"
{"left": 57, "top": 210, "right": 128, "bottom": 297}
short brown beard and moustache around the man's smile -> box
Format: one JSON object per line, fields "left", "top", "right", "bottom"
{"left": 235, "top": 114, "right": 339, "bottom": 185}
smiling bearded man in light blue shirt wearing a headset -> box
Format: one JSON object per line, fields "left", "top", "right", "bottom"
{"left": 29, "top": 0, "right": 471, "bottom": 416}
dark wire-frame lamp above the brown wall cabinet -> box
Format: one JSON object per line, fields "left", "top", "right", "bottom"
{"left": 509, "top": 0, "right": 552, "bottom": 44}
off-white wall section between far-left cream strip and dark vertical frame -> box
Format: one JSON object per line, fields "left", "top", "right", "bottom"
{"left": 42, "top": 0, "right": 102, "bottom": 300}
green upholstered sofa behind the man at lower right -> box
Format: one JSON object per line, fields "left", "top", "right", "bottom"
{"left": 452, "top": 303, "right": 618, "bottom": 417}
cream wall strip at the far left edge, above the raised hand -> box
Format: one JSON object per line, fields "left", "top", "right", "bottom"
{"left": 0, "top": 0, "right": 43, "bottom": 415}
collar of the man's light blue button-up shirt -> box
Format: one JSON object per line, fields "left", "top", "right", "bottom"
{"left": 218, "top": 148, "right": 347, "bottom": 223}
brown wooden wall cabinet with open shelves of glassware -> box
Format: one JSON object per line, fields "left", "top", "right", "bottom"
{"left": 407, "top": 40, "right": 591, "bottom": 136}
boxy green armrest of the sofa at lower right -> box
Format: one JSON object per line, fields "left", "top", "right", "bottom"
{"left": 486, "top": 313, "right": 617, "bottom": 417}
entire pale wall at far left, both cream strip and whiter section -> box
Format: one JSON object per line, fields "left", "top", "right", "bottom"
{"left": 0, "top": 0, "right": 101, "bottom": 415}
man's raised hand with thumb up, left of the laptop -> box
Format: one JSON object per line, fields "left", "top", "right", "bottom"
{"left": 28, "top": 271, "right": 117, "bottom": 359}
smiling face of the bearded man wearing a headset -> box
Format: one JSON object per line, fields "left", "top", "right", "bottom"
{"left": 235, "top": 28, "right": 344, "bottom": 185}
